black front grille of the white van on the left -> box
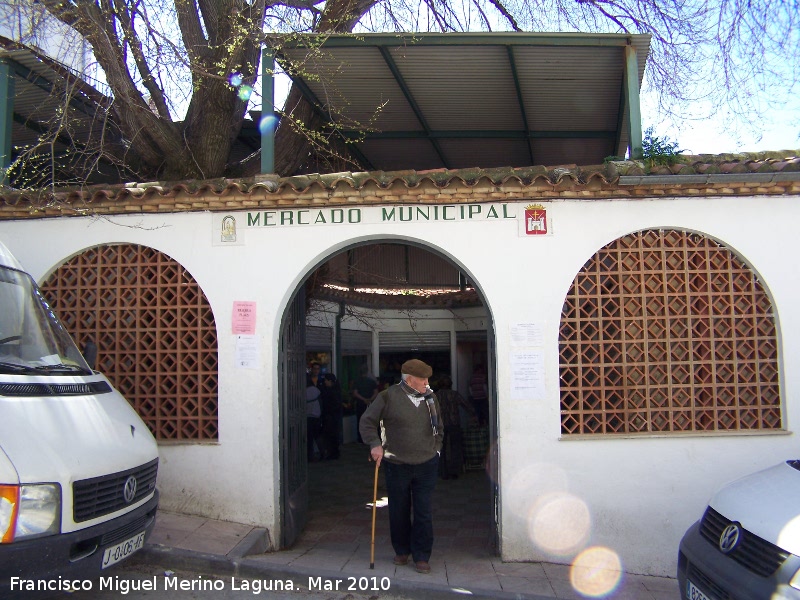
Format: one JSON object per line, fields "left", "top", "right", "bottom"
{"left": 72, "top": 458, "right": 158, "bottom": 523}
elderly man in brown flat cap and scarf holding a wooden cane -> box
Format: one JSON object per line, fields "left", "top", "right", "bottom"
{"left": 359, "top": 359, "right": 443, "bottom": 573}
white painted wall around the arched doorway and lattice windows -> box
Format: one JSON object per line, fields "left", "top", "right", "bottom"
{"left": 0, "top": 197, "right": 800, "bottom": 576}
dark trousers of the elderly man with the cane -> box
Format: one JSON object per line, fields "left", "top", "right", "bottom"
{"left": 383, "top": 454, "right": 439, "bottom": 562}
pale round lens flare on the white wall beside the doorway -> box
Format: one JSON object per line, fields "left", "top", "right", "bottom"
{"left": 528, "top": 492, "right": 592, "bottom": 556}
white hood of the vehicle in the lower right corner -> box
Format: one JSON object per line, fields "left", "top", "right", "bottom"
{"left": 709, "top": 461, "right": 800, "bottom": 555}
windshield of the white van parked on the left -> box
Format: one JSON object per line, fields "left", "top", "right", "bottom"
{"left": 0, "top": 266, "right": 92, "bottom": 375}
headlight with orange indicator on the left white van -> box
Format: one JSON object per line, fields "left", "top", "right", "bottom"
{"left": 0, "top": 483, "right": 61, "bottom": 544}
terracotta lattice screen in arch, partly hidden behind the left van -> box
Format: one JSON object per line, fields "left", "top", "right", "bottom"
{"left": 42, "top": 245, "right": 218, "bottom": 440}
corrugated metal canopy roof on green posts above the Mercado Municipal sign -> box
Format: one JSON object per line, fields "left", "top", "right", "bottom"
{"left": 276, "top": 33, "right": 650, "bottom": 171}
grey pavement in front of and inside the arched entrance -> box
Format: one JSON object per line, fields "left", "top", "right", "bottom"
{"left": 137, "top": 444, "right": 679, "bottom": 600}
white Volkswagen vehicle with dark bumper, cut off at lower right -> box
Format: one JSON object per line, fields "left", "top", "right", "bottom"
{"left": 678, "top": 460, "right": 800, "bottom": 600}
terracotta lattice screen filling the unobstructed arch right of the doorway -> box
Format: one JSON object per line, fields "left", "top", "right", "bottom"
{"left": 559, "top": 230, "right": 782, "bottom": 434}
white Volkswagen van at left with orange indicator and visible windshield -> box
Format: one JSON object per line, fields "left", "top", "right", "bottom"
{"left": 0, "top": 243, "right": 158, "bottom": 598}
